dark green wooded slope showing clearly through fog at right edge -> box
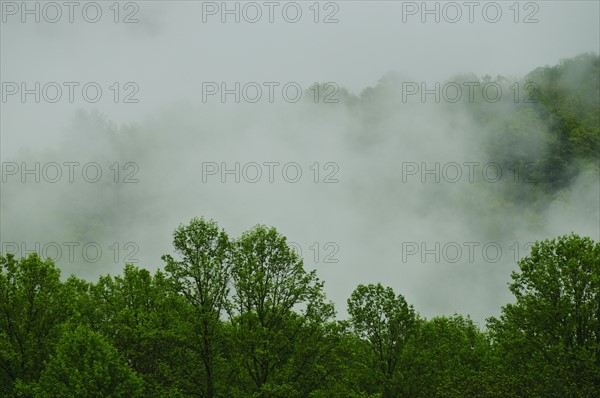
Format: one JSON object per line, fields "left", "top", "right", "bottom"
{"left": 486, "top": 54, "right": 600, "bottom": 196}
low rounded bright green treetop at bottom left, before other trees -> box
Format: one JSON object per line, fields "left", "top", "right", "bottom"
{"left": 35, "top": 325, "right": 143, "bottom": 398}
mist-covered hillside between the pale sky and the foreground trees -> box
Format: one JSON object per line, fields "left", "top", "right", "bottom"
{"left": 2, "top": 54, "right": 600, "bottom": 320}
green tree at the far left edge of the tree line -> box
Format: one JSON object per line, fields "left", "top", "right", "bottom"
{"left": 0, "top": 253, "right": 72, "bottom": 395}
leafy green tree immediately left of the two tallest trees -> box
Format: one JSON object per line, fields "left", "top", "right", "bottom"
{"left": 89, "top": 264, "right": 188, "bottom": 397}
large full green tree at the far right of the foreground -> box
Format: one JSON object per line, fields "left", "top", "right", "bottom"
{"left": 489, "top": 234, "right": 600, "bottom": 397}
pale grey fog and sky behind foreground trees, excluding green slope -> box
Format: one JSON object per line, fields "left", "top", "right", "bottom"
{"left": 0, "top": 1, "right": 600, "bottom": 322}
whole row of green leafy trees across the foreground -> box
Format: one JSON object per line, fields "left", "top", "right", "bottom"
{"left": 0, "top": 224, "right": 600, "bottom": 398}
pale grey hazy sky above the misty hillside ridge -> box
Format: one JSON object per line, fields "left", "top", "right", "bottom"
{"left": 0, "top": 1, "right": 600, "bottom": 151}
